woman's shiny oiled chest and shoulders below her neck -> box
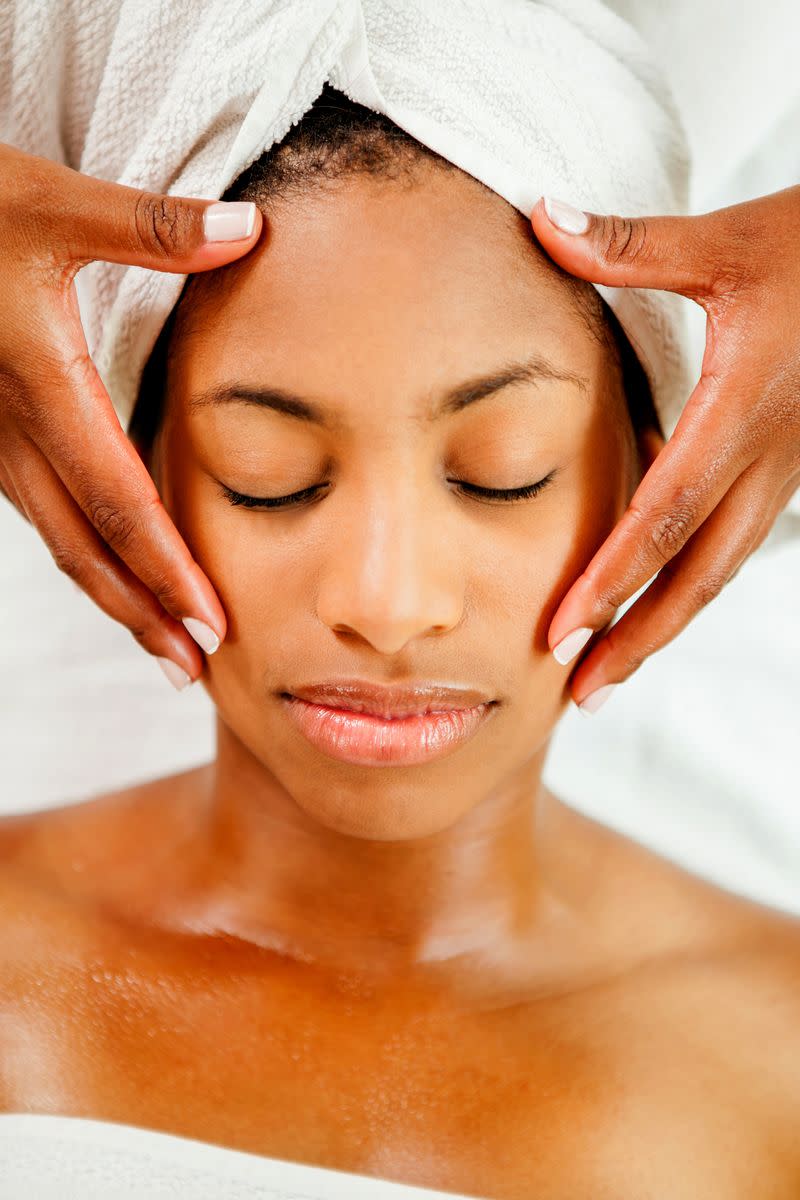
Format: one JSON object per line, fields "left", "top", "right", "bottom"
{"left": 0, "top": 768, "right": 800, "bottom": 1200}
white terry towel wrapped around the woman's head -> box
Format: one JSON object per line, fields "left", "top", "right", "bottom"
{"left": 0, "top": 0, "right": 690, "bottom": 432}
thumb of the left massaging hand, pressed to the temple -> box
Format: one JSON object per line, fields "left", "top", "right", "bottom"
{"left": 30, "top": 153, "right": 261, "bottom": 275}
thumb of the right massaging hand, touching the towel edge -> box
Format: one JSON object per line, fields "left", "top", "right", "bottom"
{"left": 530, "top": 197, "right": 724, "bottom": 299}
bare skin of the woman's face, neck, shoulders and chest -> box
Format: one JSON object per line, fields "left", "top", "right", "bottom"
{"left": 0, "top": 168, "right": 800, "bottom": 1200}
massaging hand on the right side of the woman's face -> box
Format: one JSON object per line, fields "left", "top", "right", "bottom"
{"left": 531, "top": 187, "right": 800, "bottom": 712}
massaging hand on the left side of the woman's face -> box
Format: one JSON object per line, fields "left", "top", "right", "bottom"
{"left": 0, "top": 144, "right": 261, "bottom": 682}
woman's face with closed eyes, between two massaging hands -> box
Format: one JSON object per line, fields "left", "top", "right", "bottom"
{"left": 152, "top": 166, "right": 639, "bottom": 840}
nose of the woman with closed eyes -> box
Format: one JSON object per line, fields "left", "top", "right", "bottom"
{"left": 317, "top": 477, "right": 464, "bottom": 654}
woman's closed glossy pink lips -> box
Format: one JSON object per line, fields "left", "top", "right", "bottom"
{"left": 281, "top": 679, "right": 498, "bottom": 767}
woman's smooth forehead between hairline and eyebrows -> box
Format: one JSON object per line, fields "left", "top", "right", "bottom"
{"left": 172, "top": 166, "right": 601, "bottom": 408}
